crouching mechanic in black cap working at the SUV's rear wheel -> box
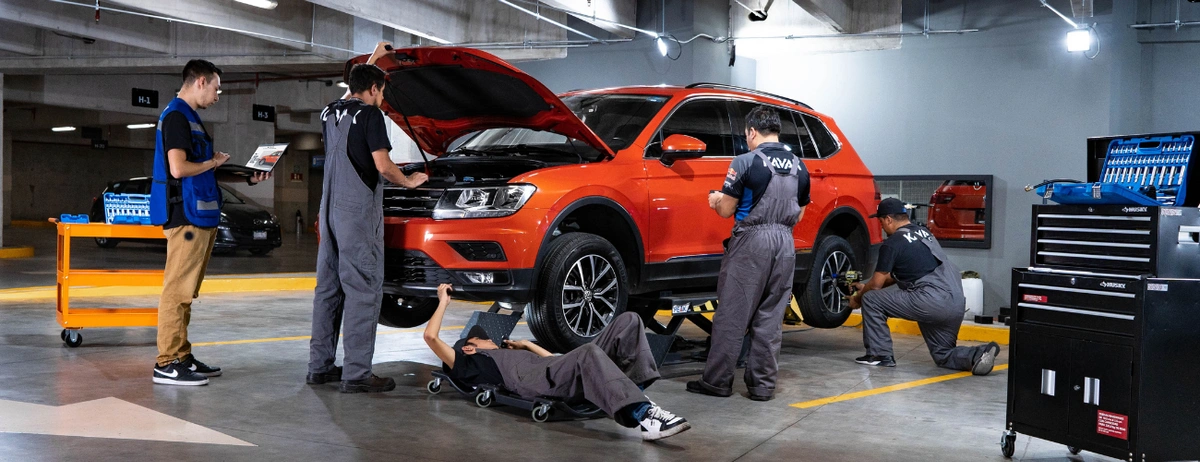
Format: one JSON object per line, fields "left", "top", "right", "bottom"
{"left": 850, "top": 198, "right": 1000, "bottom": 376}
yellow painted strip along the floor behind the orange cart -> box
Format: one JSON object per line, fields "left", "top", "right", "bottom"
{"left": 0, "top": 277, "right": 317, "bottom": 301}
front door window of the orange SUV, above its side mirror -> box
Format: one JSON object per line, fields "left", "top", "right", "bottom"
{"left": 646, "top": 100, "right": 729, "bottom": 157}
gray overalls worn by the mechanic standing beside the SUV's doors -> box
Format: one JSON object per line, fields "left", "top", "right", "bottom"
{"left": 701, "top": 150, "right": 800, "bottom": 396}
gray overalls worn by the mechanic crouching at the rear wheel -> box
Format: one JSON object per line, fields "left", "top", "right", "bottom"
{"left": 862, "top": 226, "right": 988, "bottom": 371}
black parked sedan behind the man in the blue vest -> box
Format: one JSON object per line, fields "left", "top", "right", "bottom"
{"left": 88, "top": 178, "right": 282, "bottom": 256}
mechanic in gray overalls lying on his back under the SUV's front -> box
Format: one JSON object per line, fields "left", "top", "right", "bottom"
{"left": 425, "top": 284, "right": 691, "bottom": 440}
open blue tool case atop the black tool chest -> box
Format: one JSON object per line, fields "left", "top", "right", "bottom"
{"left": 1037, "top": 134, "right": 1195, "bottom": 206}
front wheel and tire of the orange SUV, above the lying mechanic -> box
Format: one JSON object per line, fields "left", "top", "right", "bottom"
{"left": 526, "top": 233, "right": 629, "bottom": 353}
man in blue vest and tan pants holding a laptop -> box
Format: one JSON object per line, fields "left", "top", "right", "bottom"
{"left": 150, "top": 59, "right": 270, "bottom": 385}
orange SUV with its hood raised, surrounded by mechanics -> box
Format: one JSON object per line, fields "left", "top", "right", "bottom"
{"left": 347, "top": 47, "right": 881, "bottom": 350}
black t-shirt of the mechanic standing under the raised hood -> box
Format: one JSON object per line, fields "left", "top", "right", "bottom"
{"left": 322, "top": 98, "right": 391, "bottom": 191}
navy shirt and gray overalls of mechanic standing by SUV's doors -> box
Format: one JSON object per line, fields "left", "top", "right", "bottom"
{"left": 698, "top": 143, "right": 809, "bottom": 397}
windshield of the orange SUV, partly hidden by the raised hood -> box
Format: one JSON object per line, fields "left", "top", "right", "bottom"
{"left": 449, "top": 95, "right": 667, "bottom": 162}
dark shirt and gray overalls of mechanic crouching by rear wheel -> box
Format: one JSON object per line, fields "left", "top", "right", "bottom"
{"left": 862, "top": 223, "right": 990, "bottom": 371}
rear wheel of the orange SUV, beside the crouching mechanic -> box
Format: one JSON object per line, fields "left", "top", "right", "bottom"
{"left": 792, "top": 235, "right": 858, "bottom": 329}
